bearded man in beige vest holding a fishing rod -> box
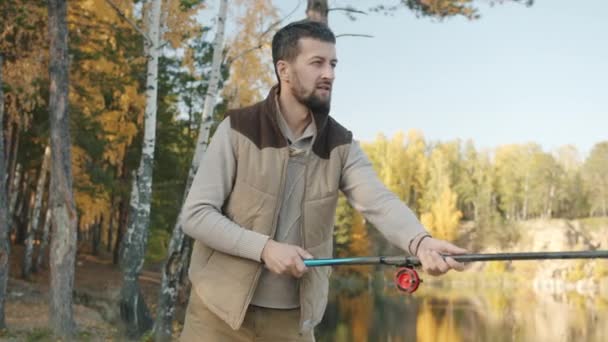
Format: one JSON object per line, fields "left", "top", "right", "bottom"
{"left": 181, "top": 21, "right": 465, "bottom": 341}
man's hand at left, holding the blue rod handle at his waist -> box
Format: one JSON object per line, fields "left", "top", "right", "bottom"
{"left": 261, "top": 240, "right": 313, "bottom": 278}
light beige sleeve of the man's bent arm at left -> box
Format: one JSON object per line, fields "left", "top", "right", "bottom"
{"left": 181, "top": 118, "right": 269, "bottom": 261}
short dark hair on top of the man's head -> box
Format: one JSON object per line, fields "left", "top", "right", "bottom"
{"left": 272, "top": 20, "right": 336, "bottom": 71}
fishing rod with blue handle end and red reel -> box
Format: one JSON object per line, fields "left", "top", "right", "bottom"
{"left": 304, "top": 250, "right": 608, "bottom": 293}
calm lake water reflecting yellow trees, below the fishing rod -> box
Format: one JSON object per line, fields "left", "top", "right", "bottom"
{"left": 316, "top": 274, "right": 608, "bottom": 342}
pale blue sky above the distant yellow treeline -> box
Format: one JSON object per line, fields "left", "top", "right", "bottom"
{"left": 214, "top": 0, "right": 608, "bottom": 155}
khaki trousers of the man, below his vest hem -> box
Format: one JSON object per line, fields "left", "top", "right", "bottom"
{"left": 180, "top": 290, "right": 315, "bottom": 342}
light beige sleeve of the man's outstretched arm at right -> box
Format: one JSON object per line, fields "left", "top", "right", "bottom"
{"left": 340, "top": 140, "right": 426, "bottom": 252}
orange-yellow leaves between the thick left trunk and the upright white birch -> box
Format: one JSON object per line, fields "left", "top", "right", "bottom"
{"left": 68, "top": 0, "right": 145, "bottom": 234}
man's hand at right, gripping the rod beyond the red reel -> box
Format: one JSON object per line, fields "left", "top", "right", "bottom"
{"left": 416, "top": 237, "right": 467, "bottom": 276}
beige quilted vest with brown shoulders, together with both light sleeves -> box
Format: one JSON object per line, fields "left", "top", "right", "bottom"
{"left": 182, "top": 88, "right": 424, "bottom": 331}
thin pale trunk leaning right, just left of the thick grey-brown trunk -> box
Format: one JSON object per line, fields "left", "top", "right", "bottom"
{"left": 23, "top": 146, "right": 51, "bottom": 279}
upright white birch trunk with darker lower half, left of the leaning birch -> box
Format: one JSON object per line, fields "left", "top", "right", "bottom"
{"left": 120, "top": 0, "right": 161, "bottom": 337}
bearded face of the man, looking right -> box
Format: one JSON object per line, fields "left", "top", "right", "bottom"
{"left": 286, "top": 38, "right": 338, "bottom": 115}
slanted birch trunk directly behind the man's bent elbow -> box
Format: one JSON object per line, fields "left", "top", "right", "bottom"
{"left": 154, "top": 0, "right": 228, "bottom": 341}
